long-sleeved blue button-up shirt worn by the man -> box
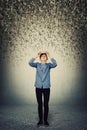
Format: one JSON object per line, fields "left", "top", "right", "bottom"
{"left": 29, "top": 58, "right": 57, "bottom": 88}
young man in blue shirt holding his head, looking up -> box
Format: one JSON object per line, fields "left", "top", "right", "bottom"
{"left": 29, "top": 52, "right": 57, "bottom": 126}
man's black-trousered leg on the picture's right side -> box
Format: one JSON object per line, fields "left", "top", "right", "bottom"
{"left": 43, "top": 88, "right": 50, "bottom": 122}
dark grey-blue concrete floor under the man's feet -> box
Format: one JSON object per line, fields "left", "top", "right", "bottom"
{"left": 0, "top": 105, "right": 87, "bottom": 130}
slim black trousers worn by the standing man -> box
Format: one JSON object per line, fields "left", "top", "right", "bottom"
{"left": 36, "top": 88, "right": 50, "bottom": 121}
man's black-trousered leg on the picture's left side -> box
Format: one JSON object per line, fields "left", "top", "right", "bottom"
{"left": 36, "top": 88, "right": 43, "bottom": 122}
